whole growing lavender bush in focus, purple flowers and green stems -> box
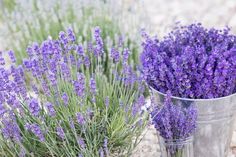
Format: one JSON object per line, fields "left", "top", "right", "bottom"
{"left": 0, "top": 27, "right": 147, "bottom": 157}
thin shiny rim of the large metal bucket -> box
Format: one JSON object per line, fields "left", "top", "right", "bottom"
{"left": 149, "top": 86, "right": 236, "bottom": 102}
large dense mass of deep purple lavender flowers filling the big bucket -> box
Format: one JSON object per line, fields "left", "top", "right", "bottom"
{"left": 141, "top": 24, "right": 236, "bottom": 99}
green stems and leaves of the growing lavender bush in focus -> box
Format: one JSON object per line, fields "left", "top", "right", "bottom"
{"left": 0, "top": 27, "right": 148, "bottom": 157}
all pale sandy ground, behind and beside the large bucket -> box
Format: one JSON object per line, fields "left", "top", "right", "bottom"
{"left": 0, "top": 0, "right": 236, "bottom": 157}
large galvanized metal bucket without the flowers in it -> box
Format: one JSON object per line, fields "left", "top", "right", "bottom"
{"left": 151, "top": 88, "right": 236, "bottom": 157}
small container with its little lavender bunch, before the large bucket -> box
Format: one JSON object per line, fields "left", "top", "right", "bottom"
{"left": 151, "top": 92, "right": 197, "bottom": 157}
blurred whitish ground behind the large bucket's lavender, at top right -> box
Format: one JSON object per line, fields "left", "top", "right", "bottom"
{"left": 143, "top": 0, "right": 236, "bottom": 35}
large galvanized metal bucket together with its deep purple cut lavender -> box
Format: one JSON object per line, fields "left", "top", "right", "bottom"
{"left": 141, "top": 24, "right": 236, "bottom": 157}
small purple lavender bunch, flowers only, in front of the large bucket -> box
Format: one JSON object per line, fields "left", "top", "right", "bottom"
{"left": 151, "top": 93, "right": 197, "bottom": 140}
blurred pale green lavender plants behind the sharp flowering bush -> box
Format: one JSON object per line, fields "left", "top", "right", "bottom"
{"left": 0, "top": 0, "right": 141, "bottom": 64}
